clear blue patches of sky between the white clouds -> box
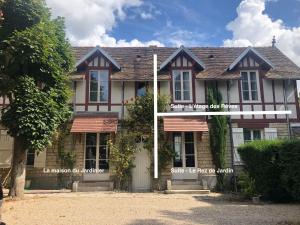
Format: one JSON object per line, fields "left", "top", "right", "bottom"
{"left": 109, "top": 0, "right": 300, "bottom": 46}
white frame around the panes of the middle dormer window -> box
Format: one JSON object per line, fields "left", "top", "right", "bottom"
{"left": 172, "top": 69, "right": 193, "bottom": 103}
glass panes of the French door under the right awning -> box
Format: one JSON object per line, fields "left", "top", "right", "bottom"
{"left": 173, "top": 132, "right": 196, "bottom": 167}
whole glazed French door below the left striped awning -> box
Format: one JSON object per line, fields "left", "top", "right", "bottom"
{"left": 83, "top": 133, "right": 110, "bottom": 181}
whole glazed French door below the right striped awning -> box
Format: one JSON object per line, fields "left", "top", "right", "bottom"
{"left": 172, "top": 132, "right": 198, "bottom": 180}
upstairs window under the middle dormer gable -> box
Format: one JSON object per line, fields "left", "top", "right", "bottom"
{"left": 173, "top": 70, "right": 192, "bottom": 101}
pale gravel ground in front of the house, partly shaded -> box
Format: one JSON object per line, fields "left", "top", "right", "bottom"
{"left": 2, "top": 193, "right": 300, "bottom": 225}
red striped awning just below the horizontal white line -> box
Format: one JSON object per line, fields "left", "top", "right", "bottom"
{"left": 164, "top": 116, "right": 208, "bottom": 132}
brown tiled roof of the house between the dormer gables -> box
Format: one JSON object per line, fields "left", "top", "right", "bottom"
{"left": 73, "top": 47, "right": 300, "bottom": 80}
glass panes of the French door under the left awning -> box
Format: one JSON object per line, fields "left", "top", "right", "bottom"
{"left": 85, "top": 133, "right": 110, "bottom": 169}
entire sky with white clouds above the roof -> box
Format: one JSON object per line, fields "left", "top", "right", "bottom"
{"left": 46, "top": 0, "right": 300, "bottom": 66}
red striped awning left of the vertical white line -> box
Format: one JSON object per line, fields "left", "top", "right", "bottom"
{"left": 71, "top": 114, "right": 118, "bottom": 133}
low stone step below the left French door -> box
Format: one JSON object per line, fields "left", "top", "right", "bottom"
{"left": 72, "top": 181, "right": 113, "bottom": 192}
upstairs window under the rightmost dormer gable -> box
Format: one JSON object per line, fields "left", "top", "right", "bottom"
{"left": 241, "top": 71, "right": 259, "bottom": 101}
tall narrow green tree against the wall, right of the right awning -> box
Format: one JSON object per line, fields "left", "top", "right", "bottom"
{"left": 208, "top": 84, "right": 227, "bottom": 190}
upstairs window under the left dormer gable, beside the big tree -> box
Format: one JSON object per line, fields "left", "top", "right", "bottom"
{"left": 89, "top": 70, "right": 109, "bottom": 102}
